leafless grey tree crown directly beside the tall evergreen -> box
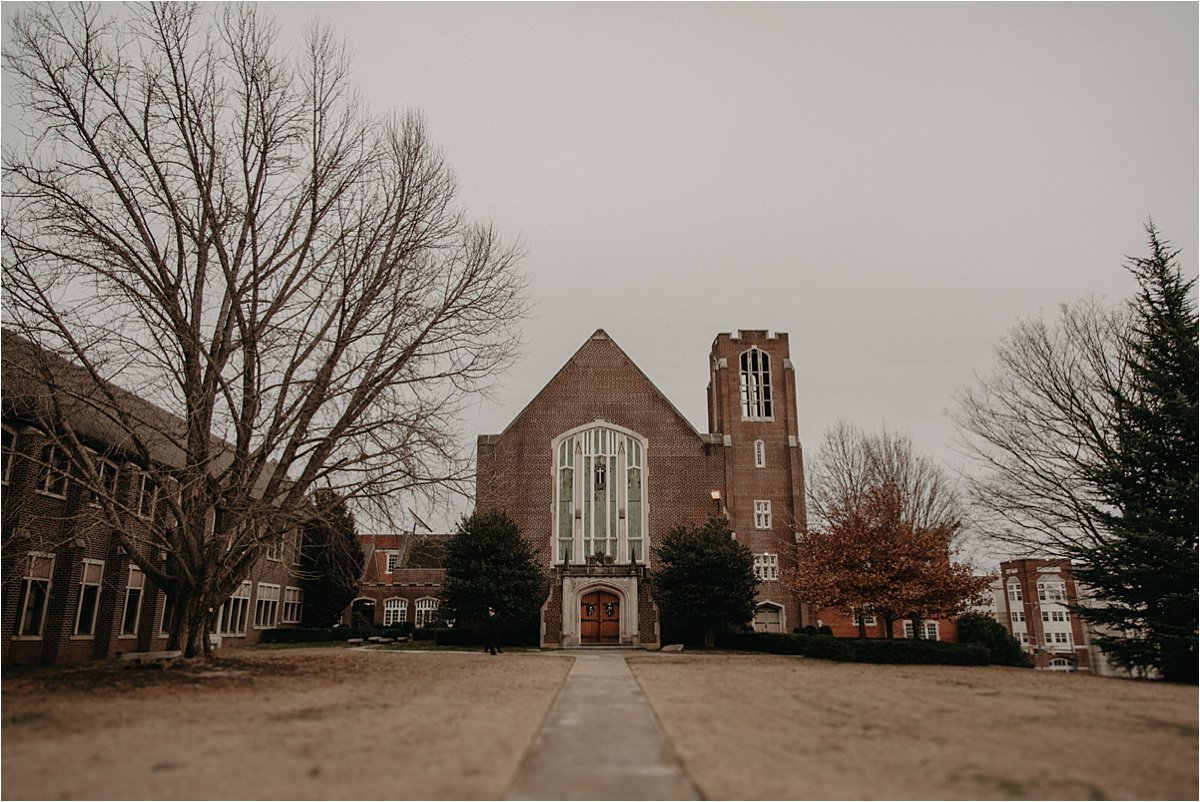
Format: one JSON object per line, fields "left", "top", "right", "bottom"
{"left": 955, "top": 299, "right": 1130, "bottom": 556}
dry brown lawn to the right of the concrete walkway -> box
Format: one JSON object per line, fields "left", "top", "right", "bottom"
{"left": 629, "top": 653, "right": 1198, "bottom": 800}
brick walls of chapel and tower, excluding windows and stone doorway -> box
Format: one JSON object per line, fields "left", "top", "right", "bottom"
{"left": 475, "top": 331, "right": 804, "bottom": 646}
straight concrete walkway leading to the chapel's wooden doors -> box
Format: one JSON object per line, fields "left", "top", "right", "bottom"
{"left": 506, "top": 651, "right": 700, "bottom": 800}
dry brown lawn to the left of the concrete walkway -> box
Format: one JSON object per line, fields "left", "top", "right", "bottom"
{"left": 0, "top": 647, "right": 571, "bottom": 800}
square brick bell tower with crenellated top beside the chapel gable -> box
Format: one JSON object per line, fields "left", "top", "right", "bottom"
{"left": 708, "top": 330, "right": 812, "bottom": 632}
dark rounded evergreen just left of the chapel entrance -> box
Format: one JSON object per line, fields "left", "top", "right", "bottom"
{"left": 442, "top": 511, "right": 547, "bottom": 628}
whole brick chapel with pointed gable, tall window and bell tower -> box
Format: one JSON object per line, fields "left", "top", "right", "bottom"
{"left": 475, "top": 330, "right": 811, "bottom": 648}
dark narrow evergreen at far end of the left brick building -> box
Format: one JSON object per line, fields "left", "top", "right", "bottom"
{"left": 300, "top": 489, "right": 366, "bottom": 627}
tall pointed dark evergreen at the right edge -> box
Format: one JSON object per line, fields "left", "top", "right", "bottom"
{"left": 1076, "top": 223, "right": 1200, "bottom": 683}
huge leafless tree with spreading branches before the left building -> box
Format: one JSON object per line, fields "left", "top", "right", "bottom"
{"left": 2, "top": 4, "right": 526, "bottom": 654}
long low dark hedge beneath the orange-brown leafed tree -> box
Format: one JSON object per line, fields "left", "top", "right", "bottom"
{"left": 716, "top": 633, "right": 989, "bottom": 665}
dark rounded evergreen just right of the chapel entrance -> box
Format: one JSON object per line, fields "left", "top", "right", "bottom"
{"left": 650, "top": 517, "right": 758, "bottom": 646}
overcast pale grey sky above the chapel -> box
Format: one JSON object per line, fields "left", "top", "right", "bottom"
{"left": 271, "top": 2, "right": 1198, "bottom": 533}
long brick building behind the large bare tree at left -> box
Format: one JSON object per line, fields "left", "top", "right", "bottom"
{"left": 0, "top": 330, "right": 304, "bottom": 665}
